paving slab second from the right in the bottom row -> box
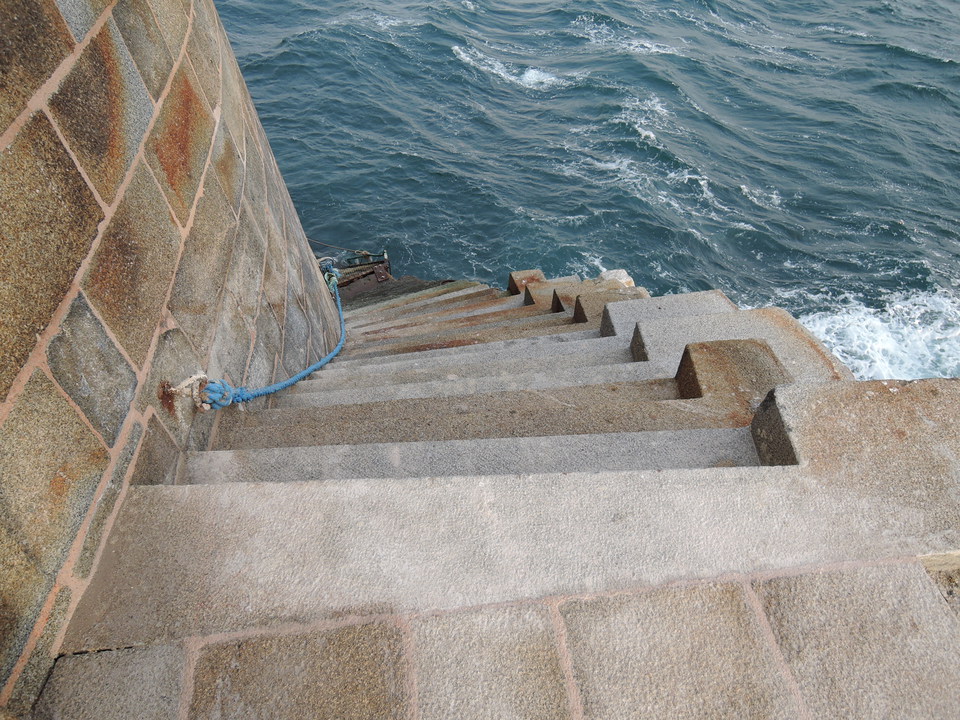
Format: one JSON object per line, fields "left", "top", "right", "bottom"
{"left": 560, "top": 584, "right": 800, "bottom": 720}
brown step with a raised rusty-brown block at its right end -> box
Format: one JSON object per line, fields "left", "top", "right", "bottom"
{"left": 216, "top": 340, "right": 786, "bottom": 450}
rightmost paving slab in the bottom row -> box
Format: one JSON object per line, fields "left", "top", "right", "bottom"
{"left": 755, "top": 564, "right": 960, "bottom": 720}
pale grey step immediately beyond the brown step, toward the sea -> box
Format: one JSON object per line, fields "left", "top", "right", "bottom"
{"left": 282, "top": 358, "right": 673, "bottom": 408}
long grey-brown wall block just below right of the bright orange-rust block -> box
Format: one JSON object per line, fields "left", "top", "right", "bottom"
{"left": 168, "top": 175, "right": 236, "bottom": 356}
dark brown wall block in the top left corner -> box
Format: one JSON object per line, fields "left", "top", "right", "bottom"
{"left": 0, "top": 0, "right": 73, "bottom": 132}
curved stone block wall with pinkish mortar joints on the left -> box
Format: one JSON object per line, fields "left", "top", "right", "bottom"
{"left": 0, "top": 0, "right": 339, "bottom": 714}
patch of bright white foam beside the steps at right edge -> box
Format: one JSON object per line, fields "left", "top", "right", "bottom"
{"left": 800, "top": 290, "right": 960, "bottom": 380}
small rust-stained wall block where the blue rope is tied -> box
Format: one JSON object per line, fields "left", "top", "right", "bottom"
{"left": 137, "top": 328, "right": 203, "bottom": 446}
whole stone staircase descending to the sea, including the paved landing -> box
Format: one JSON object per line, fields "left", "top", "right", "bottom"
{"left": 36, "top": 271, "right": 960, "bottom": 719}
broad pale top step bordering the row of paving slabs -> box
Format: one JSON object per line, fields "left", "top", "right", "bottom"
{"left": 62, "top": 459, "right": 960, "bottom": 653}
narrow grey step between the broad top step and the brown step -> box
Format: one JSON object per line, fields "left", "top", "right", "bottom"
{"left": 186, "top": 428, "right": 759, "bottom": 485}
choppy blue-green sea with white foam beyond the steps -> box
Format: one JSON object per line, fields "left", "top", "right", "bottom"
{"left": 217, "top": 0, "right": 960, "bottom": 377}
